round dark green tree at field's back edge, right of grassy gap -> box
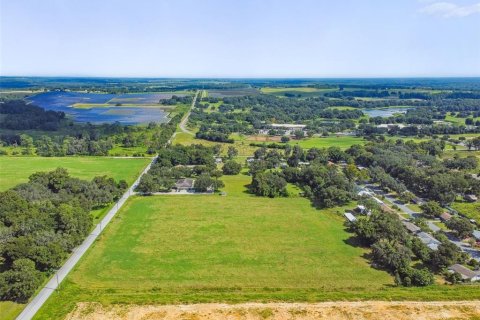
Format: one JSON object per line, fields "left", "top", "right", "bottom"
{"left": 250, "top": 172, "right": 287, "bottom": 198}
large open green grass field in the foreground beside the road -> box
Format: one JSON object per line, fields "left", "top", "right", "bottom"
{"left": 36, "top": 175, "right": 480, "bottom": 319}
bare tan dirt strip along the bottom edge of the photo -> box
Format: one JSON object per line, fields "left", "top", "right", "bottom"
{"left": 66, "top": 301, "right": 480, "bottom": 320}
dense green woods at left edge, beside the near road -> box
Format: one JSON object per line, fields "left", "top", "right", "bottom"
{"left": 0, "top": 168, "right": 127, "bottom": 303}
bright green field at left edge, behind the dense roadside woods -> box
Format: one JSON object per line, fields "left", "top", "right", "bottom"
{"left": 0, "top": 157, "right": 150, "bottom": 191}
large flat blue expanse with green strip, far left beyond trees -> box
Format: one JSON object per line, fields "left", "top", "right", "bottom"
{"left": 27, "top": 91, "right": 181, "bottom": 124}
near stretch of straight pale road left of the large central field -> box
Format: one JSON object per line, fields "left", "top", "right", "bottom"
{"left": 17, "top": 158, "right": 156, "bottom": 320}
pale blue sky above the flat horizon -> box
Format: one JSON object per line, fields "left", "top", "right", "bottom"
{"left": 0, "top": 0, "right": 480, "bottom": 78}
